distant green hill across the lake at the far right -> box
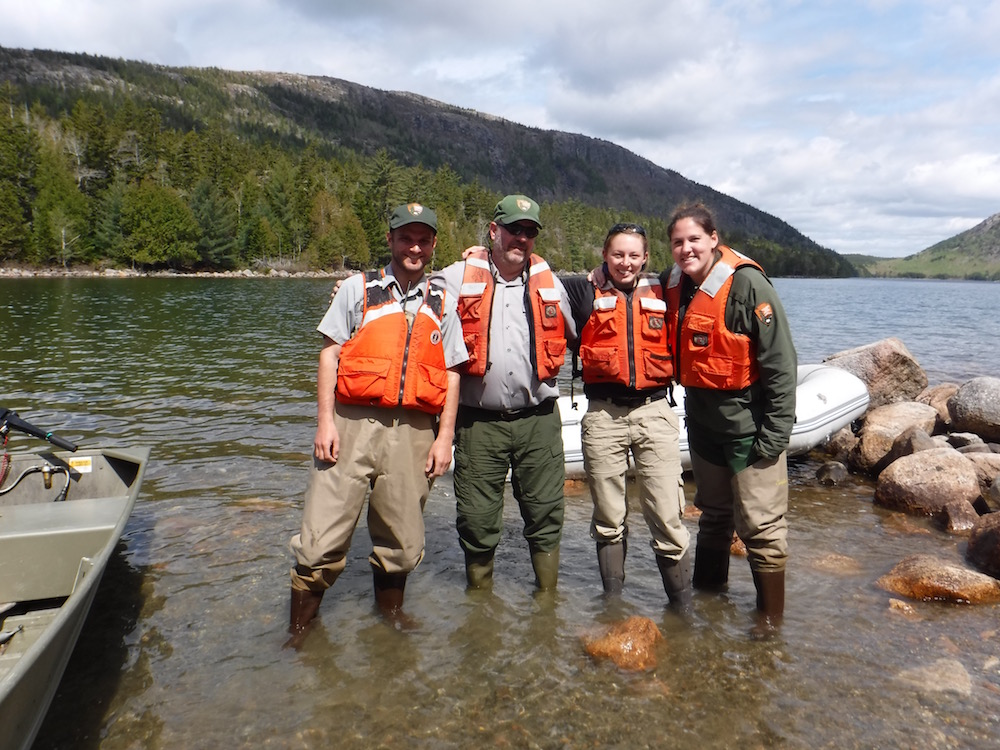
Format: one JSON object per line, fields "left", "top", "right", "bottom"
{"left": 844, "top": 214, "right": 1000, "bottom": 281}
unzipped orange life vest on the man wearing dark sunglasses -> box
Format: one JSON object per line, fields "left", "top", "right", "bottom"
{"left": 458, "top": 250, "right": 566, "bottom": 380}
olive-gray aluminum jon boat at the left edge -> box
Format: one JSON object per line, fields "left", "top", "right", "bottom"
{"left": 0, "top": 409, "right": 149, "bottom": 750}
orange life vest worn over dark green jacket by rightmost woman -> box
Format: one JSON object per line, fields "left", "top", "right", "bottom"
{"left": 667, "top": 245, "right": 764, "bottom": 391}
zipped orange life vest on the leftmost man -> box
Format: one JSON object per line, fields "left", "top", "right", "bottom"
{"left": 337, "top": 271, "right": 448, "bottom": 414}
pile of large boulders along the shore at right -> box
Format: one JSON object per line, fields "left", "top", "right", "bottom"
{"left": 817, "top": 338, "right": 1000, "bottom": 604}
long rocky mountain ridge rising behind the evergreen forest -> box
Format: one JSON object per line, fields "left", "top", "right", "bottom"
{"left": 0, "top": 48, "right": 856, "bottom": 276}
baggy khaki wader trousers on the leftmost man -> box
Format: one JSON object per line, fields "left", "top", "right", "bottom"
{"left": 291, "top": 403, "right": 435, "bottom": 591}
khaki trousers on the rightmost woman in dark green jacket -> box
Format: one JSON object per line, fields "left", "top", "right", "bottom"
{"left": 691, "top": 450, "right": 788, "bottom": 573}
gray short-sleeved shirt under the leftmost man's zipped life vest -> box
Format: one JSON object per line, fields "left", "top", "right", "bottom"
{"left": 316, "top": 265, "right": 469, "bottom": 369}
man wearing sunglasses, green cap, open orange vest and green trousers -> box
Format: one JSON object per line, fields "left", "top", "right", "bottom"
{"left": 433, "top": 195, "right": 576, "bottom": 590}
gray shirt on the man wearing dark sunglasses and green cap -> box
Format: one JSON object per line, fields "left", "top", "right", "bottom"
{"left": 434, "top": 261, "right": 577, "bottom": 411}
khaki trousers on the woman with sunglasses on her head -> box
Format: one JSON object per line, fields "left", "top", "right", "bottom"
{"left": 581, "top": 399, "right": 690, "bottom": 560}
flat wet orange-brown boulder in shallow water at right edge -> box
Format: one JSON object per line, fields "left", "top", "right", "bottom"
{"left": 875, "top": 555, "right": 1000, "bottom": 604}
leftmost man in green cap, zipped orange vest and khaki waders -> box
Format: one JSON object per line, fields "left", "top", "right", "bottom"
{"left": 289, "top": 203, "right": 467, "bottom": 646}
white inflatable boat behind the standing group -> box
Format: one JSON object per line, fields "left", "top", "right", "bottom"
{"left": 559, "top": 365, "right": 868, "bottom": 479}
